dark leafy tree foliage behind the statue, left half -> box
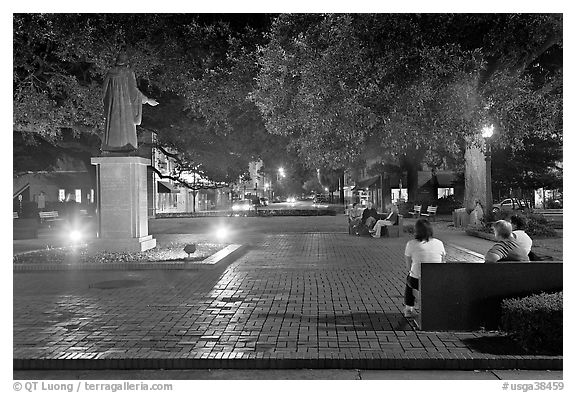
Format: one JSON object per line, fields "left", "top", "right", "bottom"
{"left": 14, "top": 14, "right": 278, "bottom": 184}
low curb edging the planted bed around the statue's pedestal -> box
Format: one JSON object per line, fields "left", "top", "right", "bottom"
{"left": 13, "top": 244, "right": 246, "bottom": 273}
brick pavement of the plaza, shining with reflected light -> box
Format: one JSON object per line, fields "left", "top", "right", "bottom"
{"left": 13, "top": 233, "right": 562, "bottom": 369}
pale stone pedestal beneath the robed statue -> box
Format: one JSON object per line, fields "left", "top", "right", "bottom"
{"left": 91, "top": 157, "right": 156, "bottom": 252}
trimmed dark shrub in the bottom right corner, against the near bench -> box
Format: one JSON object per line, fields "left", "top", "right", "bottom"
{"left": 500, "top": 292, "right": 562, "bottom": 354}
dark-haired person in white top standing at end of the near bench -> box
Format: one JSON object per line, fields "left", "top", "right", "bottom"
{"left": 404, "top": 218, "right": 446, "bottom": 317}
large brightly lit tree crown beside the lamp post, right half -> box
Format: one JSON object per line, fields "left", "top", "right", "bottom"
{"left": 253, "top": 14, "right": 562, "bottom": 205}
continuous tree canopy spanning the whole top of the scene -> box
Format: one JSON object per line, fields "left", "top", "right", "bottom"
{"left": 13, "top": 14, "right": 562, "bottom": 198}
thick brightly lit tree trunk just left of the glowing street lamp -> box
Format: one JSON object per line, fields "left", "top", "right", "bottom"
{"left": 464, "top": 139, "right": 486, "bottom": 212}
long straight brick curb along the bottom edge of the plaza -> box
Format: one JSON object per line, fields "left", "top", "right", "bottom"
{"left": 13, "top": 352, "right": 563, "bottom": 370}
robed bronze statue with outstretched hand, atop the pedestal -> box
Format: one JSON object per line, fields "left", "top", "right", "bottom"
{"left": 102, "top": 53, "right": 158, "bottom": 152}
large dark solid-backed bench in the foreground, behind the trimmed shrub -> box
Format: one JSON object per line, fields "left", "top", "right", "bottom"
{"left": 419, "top": 262, "right": 563, "bottom": 331}
